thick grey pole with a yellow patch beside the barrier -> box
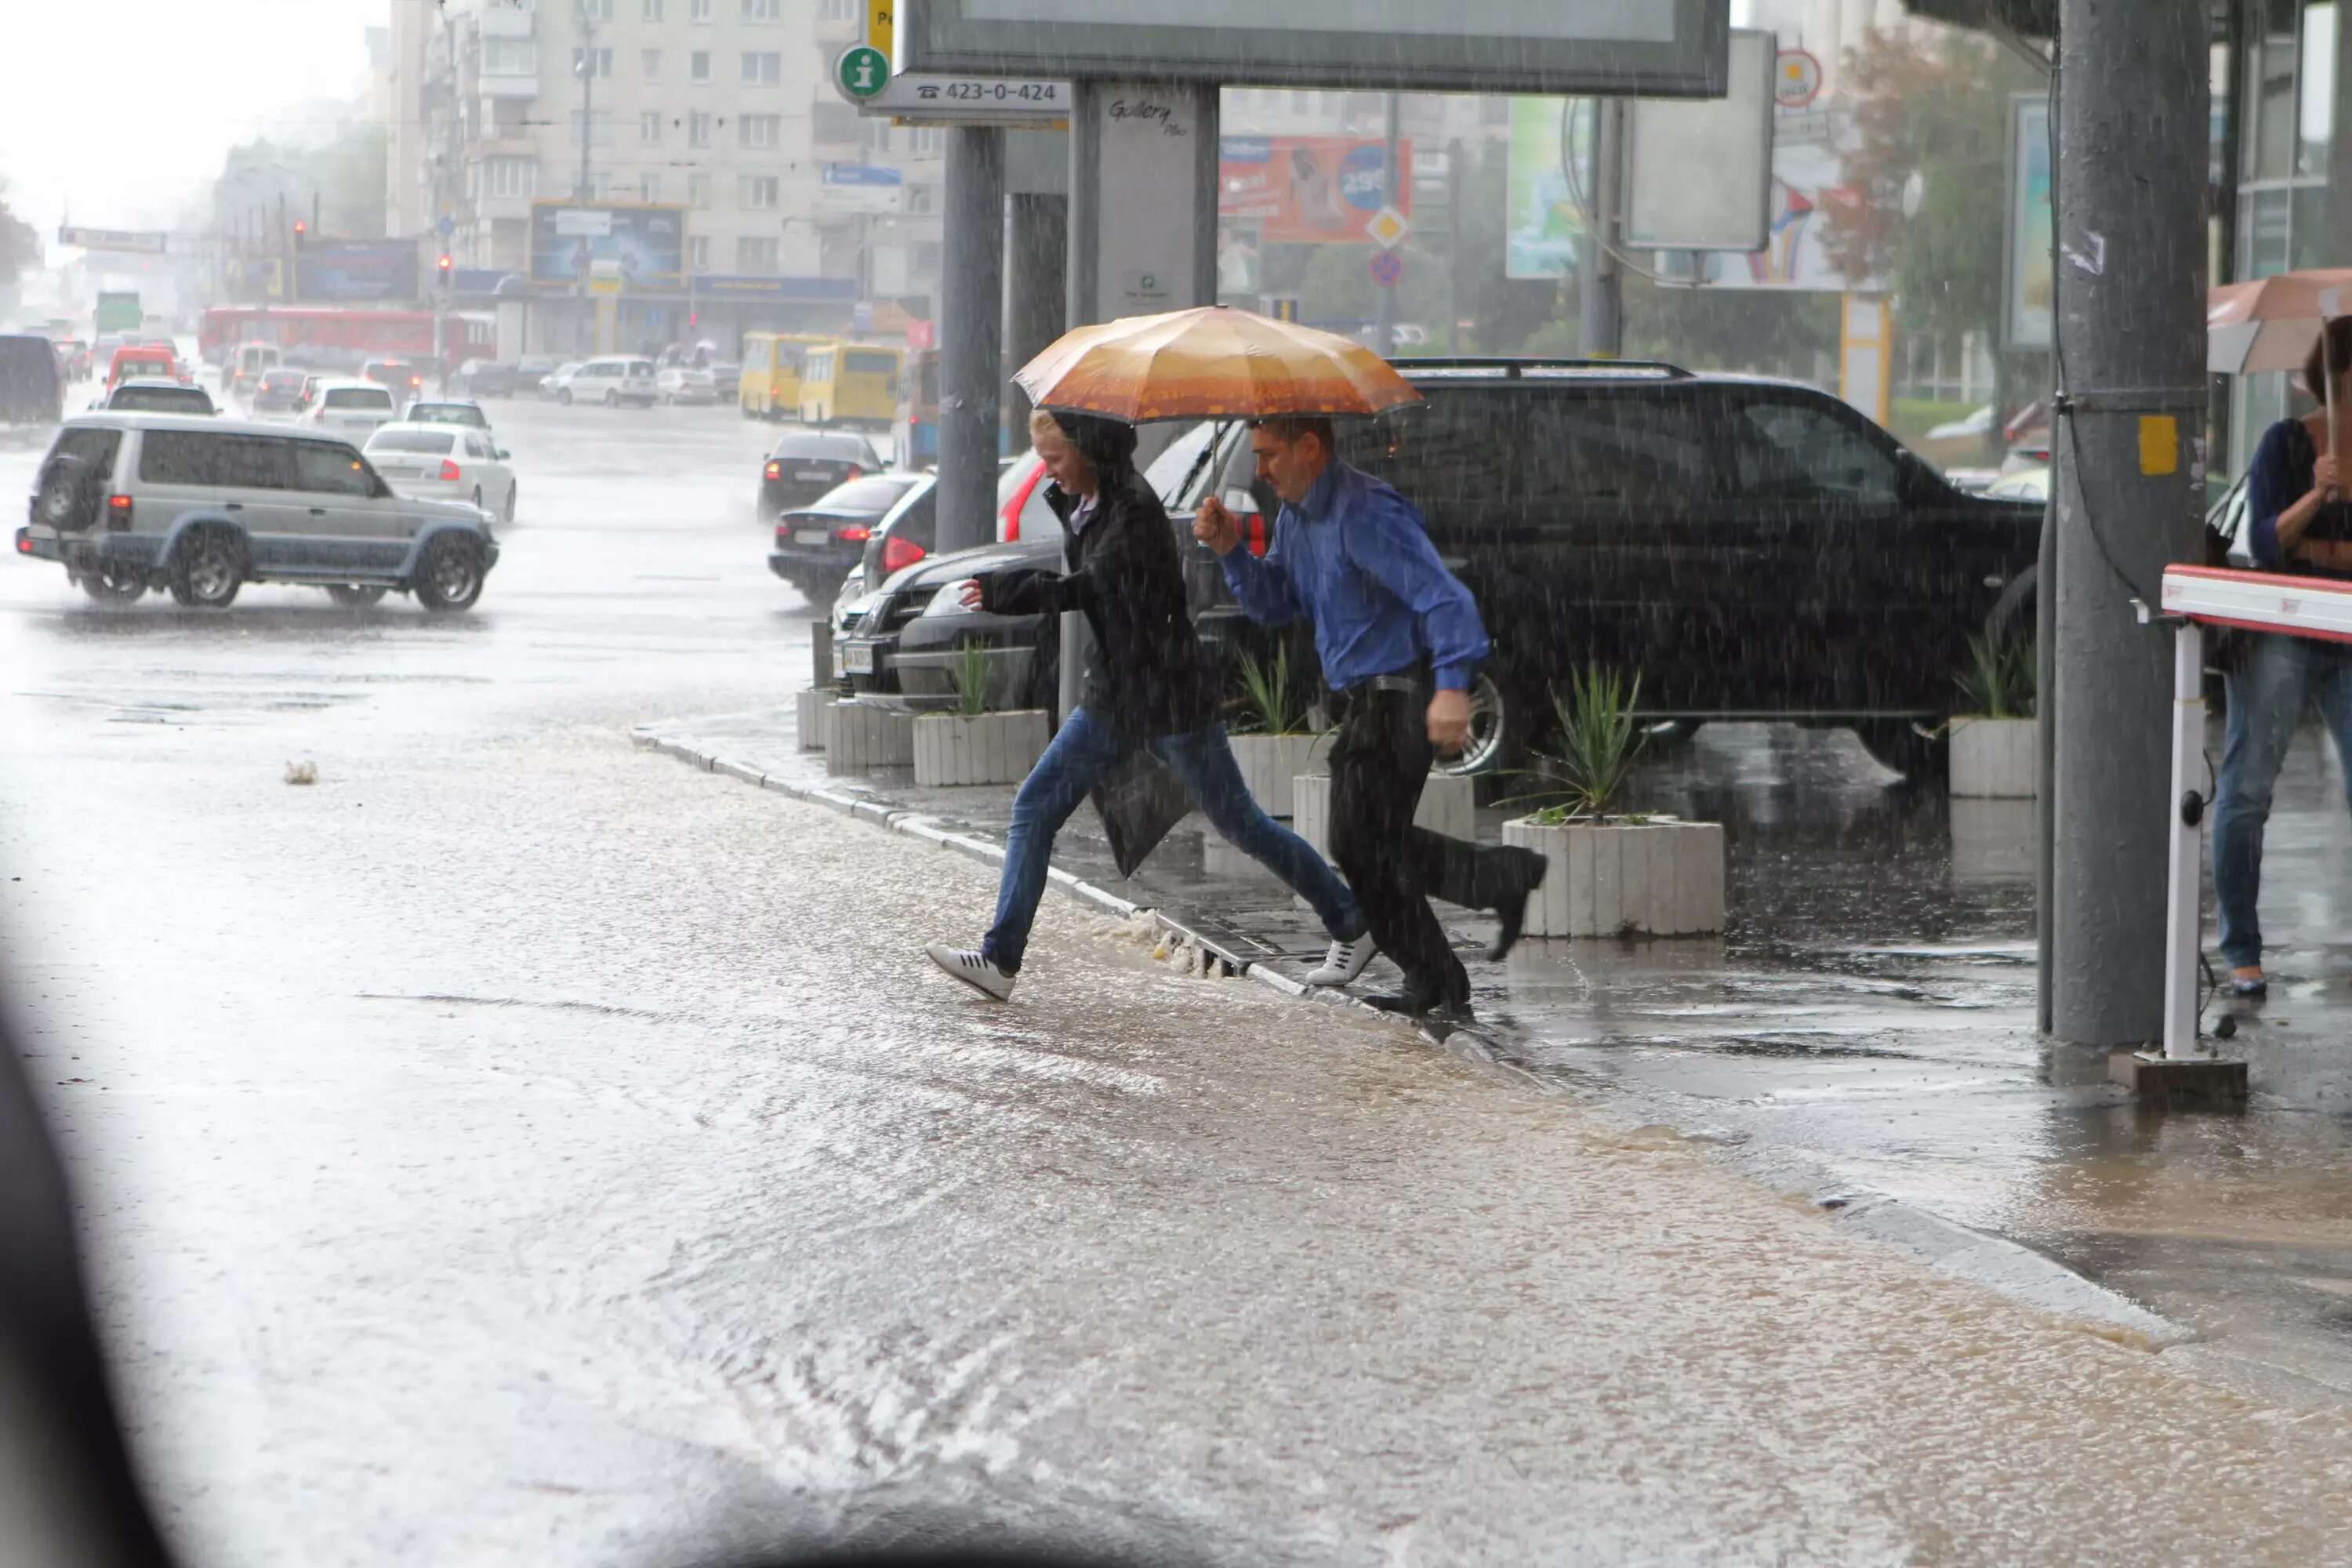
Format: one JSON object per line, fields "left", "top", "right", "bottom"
{"left": 2051, "top": 0, "right": 2209, "bottom": 1048}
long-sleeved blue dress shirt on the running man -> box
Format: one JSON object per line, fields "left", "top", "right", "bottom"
{"left": 1223, "top": 459, "right": 1486, "bottom": 691}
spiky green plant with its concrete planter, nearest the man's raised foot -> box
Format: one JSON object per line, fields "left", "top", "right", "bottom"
{"left": 1503, "top": 666, "right": 1724, "bottom": 935}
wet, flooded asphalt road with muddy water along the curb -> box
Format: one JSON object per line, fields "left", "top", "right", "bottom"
{"left": 0, "top": 390, "right": 2352, "bottom": 1566}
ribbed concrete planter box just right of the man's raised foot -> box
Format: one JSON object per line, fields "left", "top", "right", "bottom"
{"left": 1503, "top": 815, "right": 1724, "bottom": 935}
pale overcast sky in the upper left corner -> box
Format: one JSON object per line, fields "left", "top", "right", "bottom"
{"left": 0, "top": 0, "right": 386, "bottom": 254}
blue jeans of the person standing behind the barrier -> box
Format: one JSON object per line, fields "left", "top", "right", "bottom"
{"left": 2213, "top": 633, "right": 2352, "bottom": 968}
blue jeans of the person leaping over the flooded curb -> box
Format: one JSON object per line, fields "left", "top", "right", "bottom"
{"left": 981, "top": 708, "right": 1364, "bottom": 973}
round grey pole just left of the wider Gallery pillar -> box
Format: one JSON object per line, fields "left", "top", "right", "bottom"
{"left": 938, "top": 125, "right": 1004, "bottom": 555}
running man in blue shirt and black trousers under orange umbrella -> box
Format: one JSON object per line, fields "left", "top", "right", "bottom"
{"left": 1192, "top": 416, "right": 1543, "bottom": 1013}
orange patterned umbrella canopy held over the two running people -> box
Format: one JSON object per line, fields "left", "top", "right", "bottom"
{"left": 1014, "top": 306, "right": 1421, "bottom": 423}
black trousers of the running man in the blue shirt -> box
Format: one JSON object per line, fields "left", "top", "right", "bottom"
{"left": 1331, "top": 687, "right": 1510, "bottom": 1001}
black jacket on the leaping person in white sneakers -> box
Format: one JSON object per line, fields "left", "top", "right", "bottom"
{"left": 981, "top": 463, "right": 1218, "bottom": 739}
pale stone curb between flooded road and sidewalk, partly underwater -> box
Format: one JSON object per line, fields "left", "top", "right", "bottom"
{"left": 630, "top": 724, "right": 2199, "bottom": 1352}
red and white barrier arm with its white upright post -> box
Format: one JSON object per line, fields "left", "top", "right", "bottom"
{"left": 2164, "top": 567, "right": 2352, "bottom": 1058}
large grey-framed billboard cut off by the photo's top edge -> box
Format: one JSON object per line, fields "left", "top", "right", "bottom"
{"left": 894, "top": 0, "right": 1731, "bottom": 99}
